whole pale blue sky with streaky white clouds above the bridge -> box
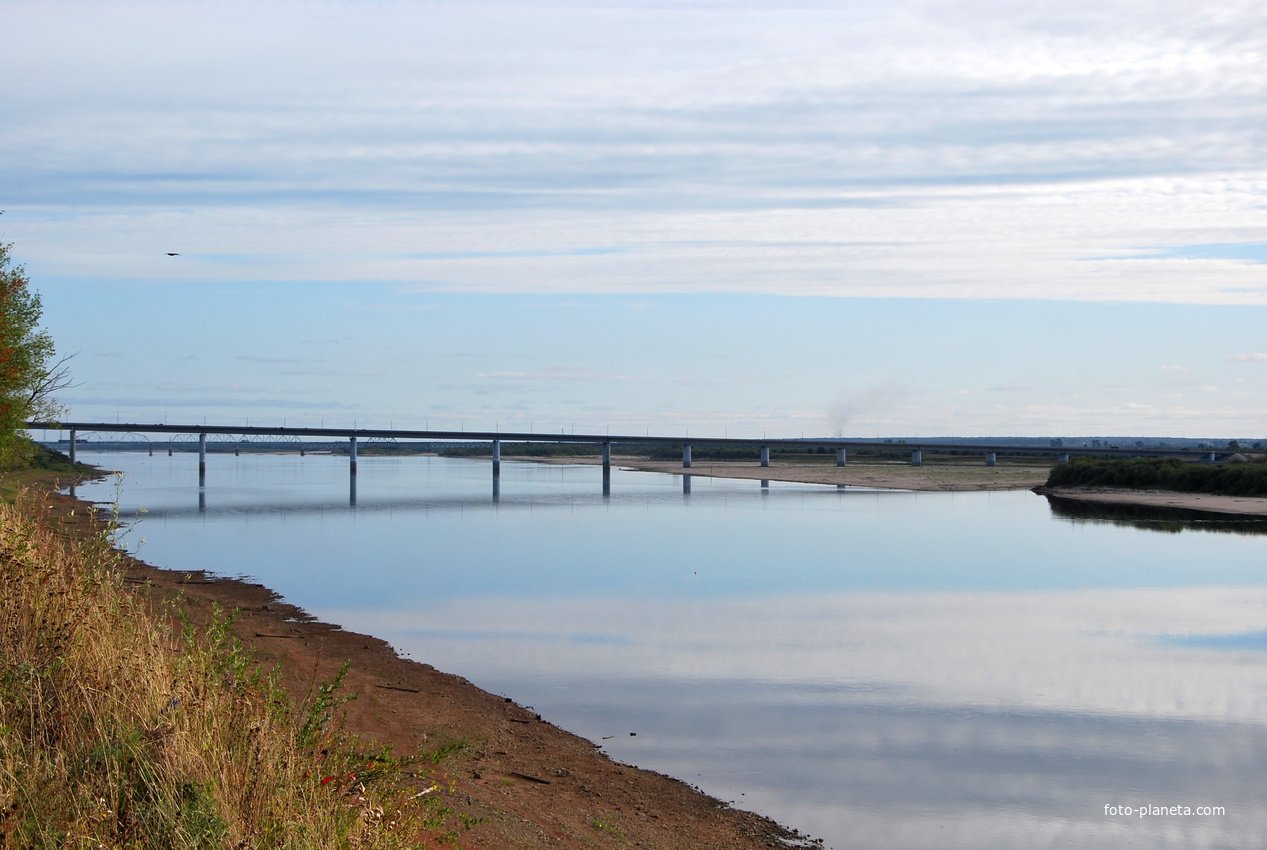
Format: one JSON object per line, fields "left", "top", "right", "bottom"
{"left": 0, "top": 0, "right": 1267, "bottom": 438}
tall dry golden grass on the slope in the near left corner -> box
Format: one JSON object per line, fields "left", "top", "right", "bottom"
{"left": 0, "top": 498, "right": 471, "bottom": 850}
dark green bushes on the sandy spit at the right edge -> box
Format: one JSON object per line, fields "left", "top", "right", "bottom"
{"left": 1047, "top": 457, "right": 1267, "bottom": 495}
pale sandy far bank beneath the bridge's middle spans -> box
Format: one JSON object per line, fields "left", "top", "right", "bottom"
{"left": 521, "top": 456, "right": 1050, "bottom": 493}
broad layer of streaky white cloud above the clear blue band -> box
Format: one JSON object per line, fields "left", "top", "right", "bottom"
{"left": 7, "top": 3, "right": 1267, "bottom": 304}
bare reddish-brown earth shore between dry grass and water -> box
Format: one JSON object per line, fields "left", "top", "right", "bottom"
{"left": 27, "top": 471, "right": 811, "bottom": 850}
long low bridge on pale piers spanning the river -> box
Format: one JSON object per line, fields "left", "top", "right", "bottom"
{"left": 27, "top": 422, "right": 1215, "bottom": 485}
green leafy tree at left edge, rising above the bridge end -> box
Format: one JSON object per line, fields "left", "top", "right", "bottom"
{"left": 0, "top": 243, "right": 70, "bottom": 466}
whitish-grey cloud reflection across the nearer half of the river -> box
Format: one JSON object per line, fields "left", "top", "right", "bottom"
{"left": 322, "top": 588, "right": 1267, "bottom": 847}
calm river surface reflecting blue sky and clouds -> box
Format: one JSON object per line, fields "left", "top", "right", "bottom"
{"left": 79, "top": 454, "right": 1267, "bottom": 850}
